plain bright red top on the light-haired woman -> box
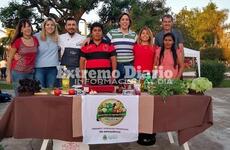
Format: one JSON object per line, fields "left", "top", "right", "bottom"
{"left": 133, "top": 44, "right": 158, "bottom": 72}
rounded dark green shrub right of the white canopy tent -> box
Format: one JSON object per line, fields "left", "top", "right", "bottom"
{"left": 201, "top": 60, "right": 226, "bottom": 87}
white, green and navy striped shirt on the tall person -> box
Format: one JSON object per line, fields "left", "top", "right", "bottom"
{"left": 106, "top": 28, "right": 137, "bottom": 63}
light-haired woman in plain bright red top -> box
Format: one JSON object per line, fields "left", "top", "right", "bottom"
{"left": 133, "top": 27, "right": 157, "bottom": 76}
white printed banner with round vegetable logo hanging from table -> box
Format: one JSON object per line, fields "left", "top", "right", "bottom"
{"left": 82, "top": 95, "right": 139, "bottom": 144}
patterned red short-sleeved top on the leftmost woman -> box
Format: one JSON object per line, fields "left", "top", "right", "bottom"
{"left": 11, "top": 37, "right": 38, "bottom": 73}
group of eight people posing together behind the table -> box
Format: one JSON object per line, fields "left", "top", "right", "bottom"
{"left": 7, "top": 13, "right": 184, "bottom": 92}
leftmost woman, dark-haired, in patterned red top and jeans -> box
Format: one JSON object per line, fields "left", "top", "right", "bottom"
{"left": 6, "top": 19, "right": 38, "bottom": 94}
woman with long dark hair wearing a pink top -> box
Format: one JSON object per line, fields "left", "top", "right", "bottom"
{"left": 154, "top": 33, "right": 184, "bottom": 79}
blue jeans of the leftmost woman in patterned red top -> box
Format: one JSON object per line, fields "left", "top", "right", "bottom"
{"left": 11, "top": 70, "right": 34, "bottom": 96}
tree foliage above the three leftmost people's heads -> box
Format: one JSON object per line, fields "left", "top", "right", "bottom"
{"left": 0, "top": 0, "right": 100, "bottom": 30}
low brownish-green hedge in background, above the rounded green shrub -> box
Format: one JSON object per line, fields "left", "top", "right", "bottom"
{"left": 200, "top": 47, "right": 224, "bottom": 60}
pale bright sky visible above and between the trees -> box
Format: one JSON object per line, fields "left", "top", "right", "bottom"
{"left": 0, "top": 0, "right": 230, "bottom": 33}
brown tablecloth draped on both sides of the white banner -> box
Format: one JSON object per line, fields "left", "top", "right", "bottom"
{"left": 0, "top": 95, "right": 213, "bottom": 144}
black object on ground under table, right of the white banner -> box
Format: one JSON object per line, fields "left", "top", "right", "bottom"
{"left": 137, "top": 133, "right": 156, "bottom": 146}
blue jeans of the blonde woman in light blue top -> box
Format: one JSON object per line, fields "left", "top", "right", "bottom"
{"left": 35, "top": 66, "right": 57, "bottom": 88}
